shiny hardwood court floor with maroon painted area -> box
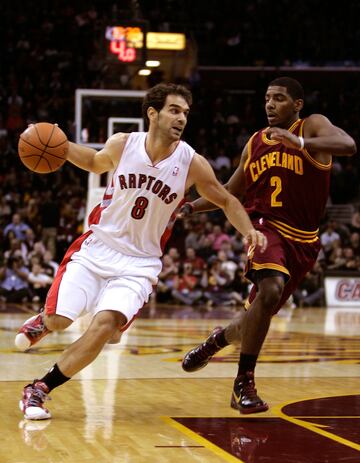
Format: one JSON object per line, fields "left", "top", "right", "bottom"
{"left": 0, "top": 305, "right": 360, "bottom": 463}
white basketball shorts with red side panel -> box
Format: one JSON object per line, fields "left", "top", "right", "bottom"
{"left": 45, "top": 231, "right": 161, "bottom": 331}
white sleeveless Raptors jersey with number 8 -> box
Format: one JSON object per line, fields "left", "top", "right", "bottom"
{"left": 89, "top": 132, "right": 195, "bottom": 257}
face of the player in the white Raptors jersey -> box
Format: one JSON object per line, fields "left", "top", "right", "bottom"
{"left": 158, "top": 95, "right": 190, "bottom": 141}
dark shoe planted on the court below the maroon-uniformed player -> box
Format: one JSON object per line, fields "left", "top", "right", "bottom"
{"left": 230, "top": 371, "right": 269, "bottom": 414}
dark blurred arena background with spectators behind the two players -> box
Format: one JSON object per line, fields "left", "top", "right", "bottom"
{"left": 0, "top": 0, "right": 360, "bottom": 308}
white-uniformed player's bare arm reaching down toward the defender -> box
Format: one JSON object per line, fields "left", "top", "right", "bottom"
{"left": 189, "top": 154, "right": 267, "bottom": 250}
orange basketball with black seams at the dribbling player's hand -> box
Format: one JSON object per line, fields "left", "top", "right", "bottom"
{"left": 18, "top": 122, "right": 69, "bottom": 174}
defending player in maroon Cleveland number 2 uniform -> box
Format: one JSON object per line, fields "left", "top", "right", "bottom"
{"left": 182, "top": 77, "right": 356, "bottom": 413}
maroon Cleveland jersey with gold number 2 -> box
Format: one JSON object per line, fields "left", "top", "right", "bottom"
{"left": 244, "top": 119, "right": 331, "bottom": 243}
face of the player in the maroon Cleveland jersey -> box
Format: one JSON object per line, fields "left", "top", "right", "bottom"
{"left": 265, "top": 86, "right": 302, "bottom": 129}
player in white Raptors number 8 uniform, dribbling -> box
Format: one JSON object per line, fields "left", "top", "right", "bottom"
{"left": 15, "top": 84, "right": 266, "bottom": 420}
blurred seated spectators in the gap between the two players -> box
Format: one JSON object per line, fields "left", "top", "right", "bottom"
{"left": 157, "top": 218, "right": 249, "bottom": 307}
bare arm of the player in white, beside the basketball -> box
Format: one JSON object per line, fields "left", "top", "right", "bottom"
{"left": 67, "top": 133, "right": 128, "bottom": 174}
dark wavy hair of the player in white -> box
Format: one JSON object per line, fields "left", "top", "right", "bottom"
{"left": 142, "top": 84, "right": 192, "bottom": 127}
